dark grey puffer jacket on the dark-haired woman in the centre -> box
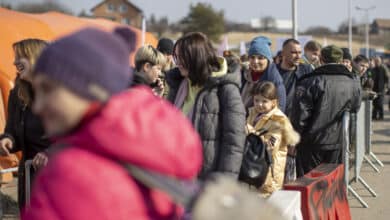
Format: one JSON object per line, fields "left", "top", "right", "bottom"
{"left": 167, "top": 65, "right": 246, "bottom": 179}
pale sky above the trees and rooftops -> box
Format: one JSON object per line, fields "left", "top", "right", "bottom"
{"left": 0, "top": 0, "right": 390, "bottom": 30}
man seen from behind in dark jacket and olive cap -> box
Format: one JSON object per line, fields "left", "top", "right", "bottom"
{"left": 291, "top": 46, "right": 361, "bottom": 176}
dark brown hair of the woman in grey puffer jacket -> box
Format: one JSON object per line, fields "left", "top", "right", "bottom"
{"left": 173, "top": 32, "right": 221, "bottom": 86}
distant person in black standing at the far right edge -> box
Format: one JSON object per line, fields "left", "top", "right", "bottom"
{"left": 372, "top": 56, "right": 389, "bottom": 120}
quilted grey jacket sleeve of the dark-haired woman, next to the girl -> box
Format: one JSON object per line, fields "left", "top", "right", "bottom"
{"left": 218, "top": 84, "right": 246, "bottom": 178}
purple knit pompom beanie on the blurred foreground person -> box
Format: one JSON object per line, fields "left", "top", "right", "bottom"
{"left": 34, "top": 28, "right": 135, "bottom": 101}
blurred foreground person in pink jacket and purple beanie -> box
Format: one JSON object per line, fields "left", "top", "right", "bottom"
{"left": 21, "top": 28, "right": 202, "bottom": 220}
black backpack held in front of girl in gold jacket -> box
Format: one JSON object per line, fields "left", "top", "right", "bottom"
{"left": 239, "top": 130, "right": 272, "bottom": 188}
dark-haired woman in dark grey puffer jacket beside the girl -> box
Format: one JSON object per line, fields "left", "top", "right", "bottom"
{"left": 167, "top": 33, "right": 246, "bottom": 179}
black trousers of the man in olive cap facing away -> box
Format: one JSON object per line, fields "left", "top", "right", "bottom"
{"left": 296, "top": 148, "right": 342, "bottom": 177}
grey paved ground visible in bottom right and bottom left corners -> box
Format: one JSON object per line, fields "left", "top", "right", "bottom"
{"left": 1, "top": 113, "right": 390, "bottom": 220}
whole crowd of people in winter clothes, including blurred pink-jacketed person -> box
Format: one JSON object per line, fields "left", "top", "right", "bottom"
{"left": 0, "top": 25, "right": 388, "bottom": 219}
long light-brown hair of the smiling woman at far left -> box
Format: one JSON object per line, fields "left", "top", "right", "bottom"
{"left": 12, "top": 39, "right": 47, "bottom": 106}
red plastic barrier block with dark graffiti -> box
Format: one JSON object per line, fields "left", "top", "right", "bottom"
{"left": 284, "top": 164, "right": 351, "bottom": 220}
